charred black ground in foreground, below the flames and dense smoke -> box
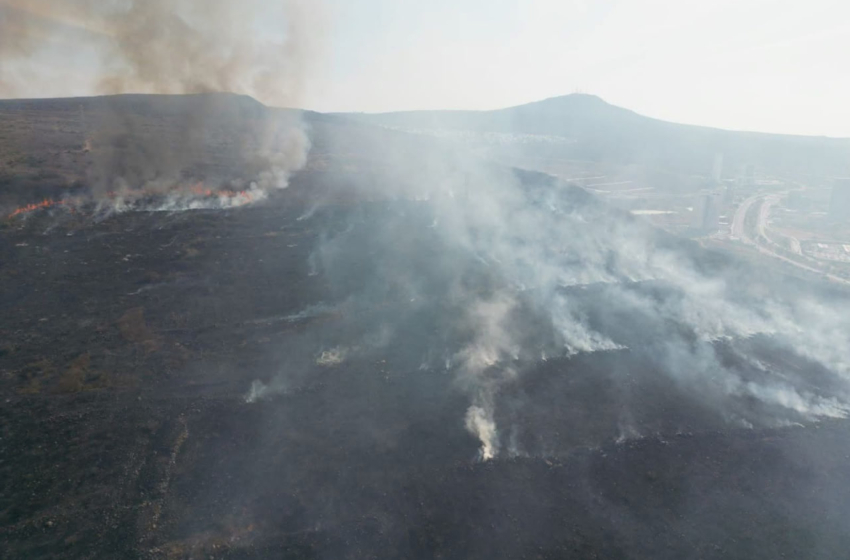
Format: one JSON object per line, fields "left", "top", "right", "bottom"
{"left": 0, "top": 175, "right": 850, "bottom": 559}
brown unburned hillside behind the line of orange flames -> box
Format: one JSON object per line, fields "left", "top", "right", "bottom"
{"left": 0, "top": 93, "right": 450, "bottom": 210}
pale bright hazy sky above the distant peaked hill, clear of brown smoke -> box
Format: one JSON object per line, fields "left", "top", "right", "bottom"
{"left": 0, "top": 0, "right": 850, "bottom": 137}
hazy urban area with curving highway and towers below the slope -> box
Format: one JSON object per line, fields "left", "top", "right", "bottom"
{"left": 578, "top": 154, "right": 850, "bottom": 284}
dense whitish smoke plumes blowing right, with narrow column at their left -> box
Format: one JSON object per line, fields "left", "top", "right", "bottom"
{"left": 441, "top": 168, "right": 850, "bottom": 458}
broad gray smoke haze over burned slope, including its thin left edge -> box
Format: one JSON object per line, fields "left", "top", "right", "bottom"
{"left": 284, "top": 141, "right": 850, "bottom": 460}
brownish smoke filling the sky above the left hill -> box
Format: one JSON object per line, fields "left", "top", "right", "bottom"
{"left": 0, "top": 0, "right": 324, "bottom": 106}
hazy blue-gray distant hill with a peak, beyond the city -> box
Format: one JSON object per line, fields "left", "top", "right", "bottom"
{"left": 338, "top": 93, "right": 850, "bottom": 179}
